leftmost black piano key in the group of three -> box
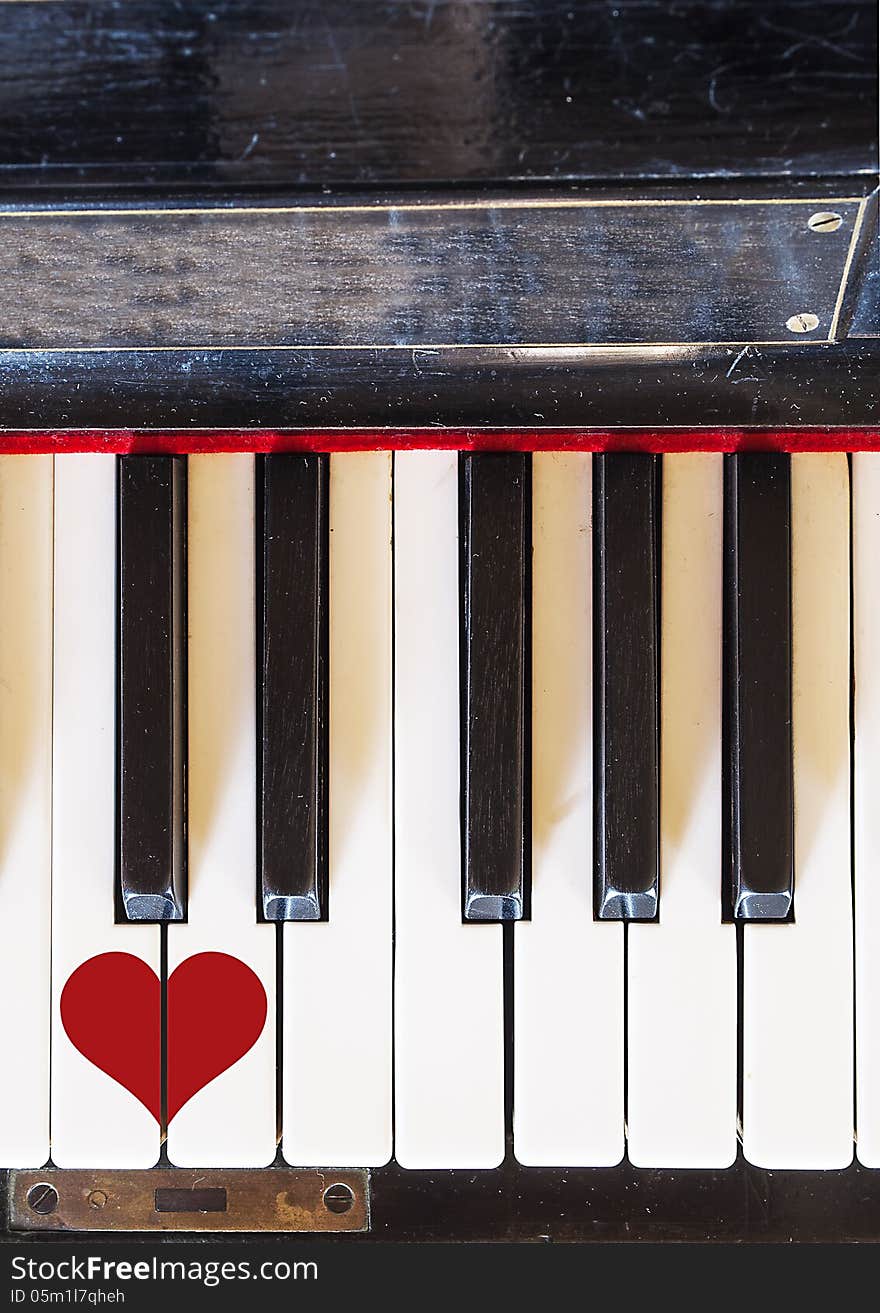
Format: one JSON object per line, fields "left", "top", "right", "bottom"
{"left": 462, "top": 453, "right": 532, "bottom": 920}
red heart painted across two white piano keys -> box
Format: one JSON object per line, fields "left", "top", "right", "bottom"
{"left": 60, "top": 953, "right": 267, "bottom": 1121}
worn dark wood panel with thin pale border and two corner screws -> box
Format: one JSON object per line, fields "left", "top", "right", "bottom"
{"left": 0, "top": 197, "right": 862, "bottom": 351}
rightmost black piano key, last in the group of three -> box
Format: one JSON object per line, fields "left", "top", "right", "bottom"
{"left": 724, "top": 453, "right": 795, "bottom": 920}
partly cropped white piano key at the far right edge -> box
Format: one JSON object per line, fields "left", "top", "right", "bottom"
{"left": 852, "top": 452, "right": 880, "bottom": 1167}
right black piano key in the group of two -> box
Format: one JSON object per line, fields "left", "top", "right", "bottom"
{"left": 257, "top": 456, "right": 330, "bottom": 920}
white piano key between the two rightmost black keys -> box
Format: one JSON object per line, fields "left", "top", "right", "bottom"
{"left": 627, "top": 454, "right": 737, "bottom": 1167}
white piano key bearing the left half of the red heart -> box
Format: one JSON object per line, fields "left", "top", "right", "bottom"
{"left": 51, "top": 456, "right": 159, "bottom": 1167}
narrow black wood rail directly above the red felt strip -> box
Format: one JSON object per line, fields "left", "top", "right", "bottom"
{"left": 0, "top": 339, "right": 880, "bottom": 428}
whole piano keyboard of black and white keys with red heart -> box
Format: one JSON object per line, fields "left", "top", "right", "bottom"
{"left": 0, "top": 452, "right": 880, "bottom": 1169}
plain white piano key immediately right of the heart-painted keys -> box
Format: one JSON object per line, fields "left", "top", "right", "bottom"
{"left": 282, "top": 452, "right": 393, "bottom": 1167}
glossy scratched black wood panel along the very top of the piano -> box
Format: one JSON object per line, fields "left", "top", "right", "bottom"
{"left": 0, "top": 0, "right": 877, "bottom": 189}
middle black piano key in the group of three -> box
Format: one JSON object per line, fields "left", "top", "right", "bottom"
{"left": 594, "top": 453, "right": 659, "bottom": 920}
